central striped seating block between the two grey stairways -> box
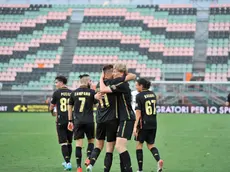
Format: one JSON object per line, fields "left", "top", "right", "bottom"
{"left": 74, "top": 5, "right": 196, "bottom": 87}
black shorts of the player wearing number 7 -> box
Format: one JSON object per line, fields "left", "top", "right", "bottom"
{"left": 74, "top": 123, "right": 95, "bottom": 140}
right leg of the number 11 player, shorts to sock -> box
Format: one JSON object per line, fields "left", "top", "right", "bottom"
{"left": 104, "top": 120, "right": 119, "bottom": 172}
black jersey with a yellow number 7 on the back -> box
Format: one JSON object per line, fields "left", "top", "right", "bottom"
{"left": 69, "top": 87, "right": 95, "bottom": 124}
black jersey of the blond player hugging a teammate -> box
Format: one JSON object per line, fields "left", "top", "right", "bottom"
{"left": 110, "top": 82, "right": 135, "bottom": 121}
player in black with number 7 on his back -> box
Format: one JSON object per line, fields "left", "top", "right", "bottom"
{"left": 68, "top": 74, "right": 96, "bottom": 172}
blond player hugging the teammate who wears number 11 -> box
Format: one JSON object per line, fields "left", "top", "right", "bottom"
{"left": 100, "top": 64, "right": 135, "bottom": 172}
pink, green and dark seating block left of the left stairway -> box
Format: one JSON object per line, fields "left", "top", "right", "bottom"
{"left": 0, "top": 5, "right": 72, "bottom": 90}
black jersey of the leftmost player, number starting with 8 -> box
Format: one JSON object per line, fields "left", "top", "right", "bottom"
{"left": 51, "top": 87, "right": 71, "bottom": 125}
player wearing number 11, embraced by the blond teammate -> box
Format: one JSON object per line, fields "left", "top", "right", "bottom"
{"left": 87, "top": 65, "right": 136, "bottom": 172}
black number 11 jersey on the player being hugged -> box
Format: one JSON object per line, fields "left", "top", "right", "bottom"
{"left": 96, "top": 77, "right": 124, "bottom": 123}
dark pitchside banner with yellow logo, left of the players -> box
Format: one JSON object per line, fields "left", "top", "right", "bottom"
{"left": 0, "top": 104, "right": 49, "bottom": 112}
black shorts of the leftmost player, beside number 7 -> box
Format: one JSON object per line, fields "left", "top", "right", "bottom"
{"left": 56, "top": 124, "right": 73, "bottom": 144}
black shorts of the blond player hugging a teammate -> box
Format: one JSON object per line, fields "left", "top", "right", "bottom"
{"left": 117, "top": 121, "right": 135, "bottom": 140}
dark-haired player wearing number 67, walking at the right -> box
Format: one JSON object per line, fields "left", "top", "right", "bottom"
{"left": 133, "top": 78, "right": 163, "bottom": 172}
